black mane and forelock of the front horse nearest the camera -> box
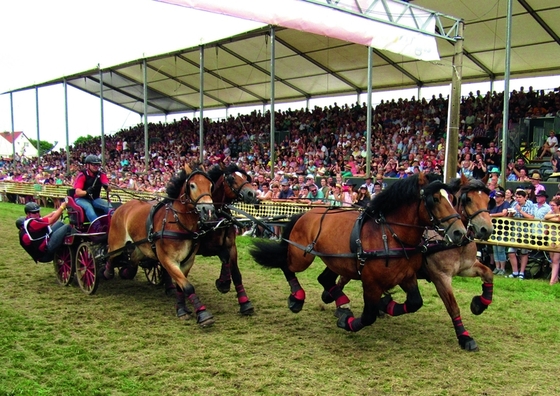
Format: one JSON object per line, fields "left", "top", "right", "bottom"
{"left": 365, "top": 175, "right": 448, "bottom": 215}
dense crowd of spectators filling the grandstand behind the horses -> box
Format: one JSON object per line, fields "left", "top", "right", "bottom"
{"left": 0, "top": 87, "right": 560, "bottom": 282}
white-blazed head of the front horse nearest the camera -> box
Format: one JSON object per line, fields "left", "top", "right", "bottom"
{"left": 418, "top": 173, "right": 467, "bottom": 245}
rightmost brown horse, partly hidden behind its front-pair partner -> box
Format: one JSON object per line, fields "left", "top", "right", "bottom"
{"left": 376, "top": 175, "right": 495, "bottom": 351}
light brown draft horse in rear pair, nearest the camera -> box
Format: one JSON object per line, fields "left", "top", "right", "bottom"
{"left": 104, "top": 163, "right": 215, "bottom": 326}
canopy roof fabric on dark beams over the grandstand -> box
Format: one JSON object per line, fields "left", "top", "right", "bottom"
{"left": 4, "top": 0, "right": 560, "bottom": 115}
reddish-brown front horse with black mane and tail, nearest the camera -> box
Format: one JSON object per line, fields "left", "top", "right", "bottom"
{"left": 250, "top": 174, "right": 467, "bottom": 332}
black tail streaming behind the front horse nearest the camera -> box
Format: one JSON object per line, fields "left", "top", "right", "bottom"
{"left": 249, "top": 213, "right": 303, "bottom": 268}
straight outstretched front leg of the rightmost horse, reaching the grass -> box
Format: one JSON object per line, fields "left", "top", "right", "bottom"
{"left": 430, "top": 271, "right": 480, "bottom": 352}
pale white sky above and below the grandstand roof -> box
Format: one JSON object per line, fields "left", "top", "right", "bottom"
{"left": 0, "top": 0, "right": 560, "bottom": 146}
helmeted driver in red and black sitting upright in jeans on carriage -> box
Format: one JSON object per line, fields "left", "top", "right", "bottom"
{"left": 74, "top": 154, "right": 111, "bottom": 222}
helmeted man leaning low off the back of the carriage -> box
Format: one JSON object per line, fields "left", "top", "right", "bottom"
{"left": 16, "top": 202, "right": 71, "bottom": 263}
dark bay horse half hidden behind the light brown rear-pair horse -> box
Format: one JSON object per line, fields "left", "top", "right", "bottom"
{"left": 167, "top": 164, "right": 259, "bottom": 315}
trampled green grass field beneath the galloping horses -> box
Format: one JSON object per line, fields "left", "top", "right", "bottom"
{"left": 0, "top": 203, "right": 560, "bottom": 396}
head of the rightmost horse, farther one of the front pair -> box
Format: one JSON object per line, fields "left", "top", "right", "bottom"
{"left": 451, "top": 174, "right": 496, "bottom": 240}
